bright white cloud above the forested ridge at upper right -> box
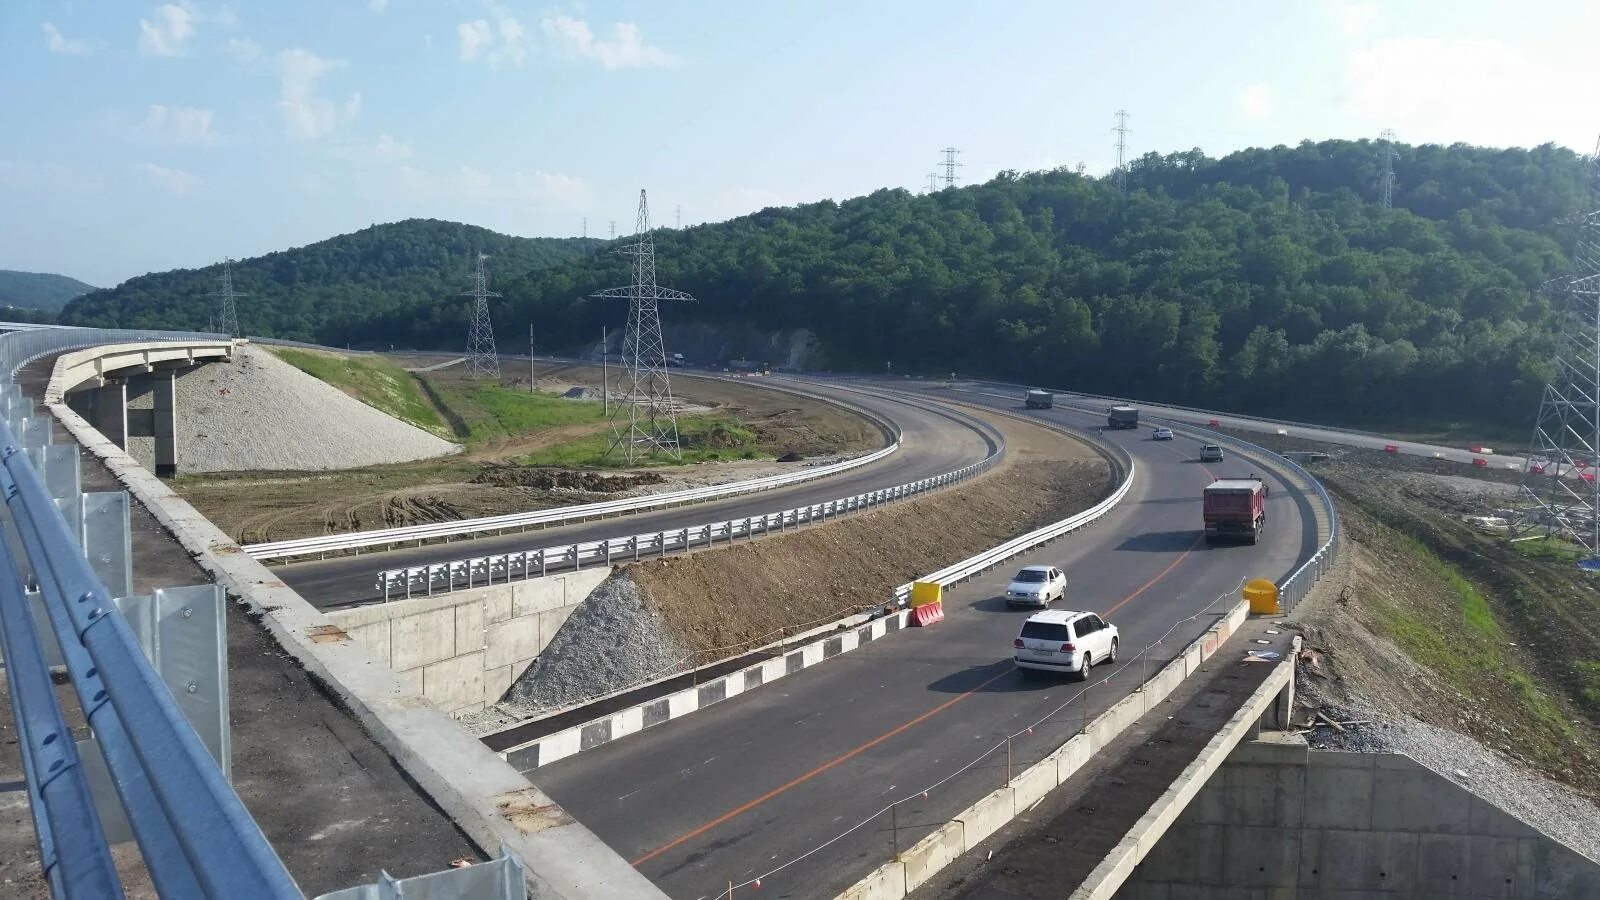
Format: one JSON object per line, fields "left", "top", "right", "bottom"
{"left": 1344, "top": 37, "right": 1600, "bottom": 152}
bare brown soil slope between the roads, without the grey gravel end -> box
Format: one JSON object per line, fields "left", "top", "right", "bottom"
{"left": 630, "top": 406, "right": 1112, "bottom": 650}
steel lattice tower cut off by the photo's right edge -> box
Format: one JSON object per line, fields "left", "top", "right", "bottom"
{"left": 1512, "top": 136, "right": 1600, "bottom": 552}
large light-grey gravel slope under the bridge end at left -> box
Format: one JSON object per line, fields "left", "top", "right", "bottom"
{"left": 128, "top": 344, "right": 461, "bottom": 472}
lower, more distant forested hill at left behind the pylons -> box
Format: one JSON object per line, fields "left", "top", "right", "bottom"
{"left": 61, "top": 219, "right": 605, "bottom": 339}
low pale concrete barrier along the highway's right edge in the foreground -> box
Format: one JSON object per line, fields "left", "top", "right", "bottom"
{"left": 838, "top": 602, "right": 1254, "bottom": 900}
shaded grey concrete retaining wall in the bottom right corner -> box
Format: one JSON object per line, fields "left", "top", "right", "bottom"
{"left": 1115, "top": 741, "right": 1600, "bottom": 900}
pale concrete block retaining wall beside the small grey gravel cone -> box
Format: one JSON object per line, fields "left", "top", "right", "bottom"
{"left": 328, "top": 567, "right": 611, "bottom": 716}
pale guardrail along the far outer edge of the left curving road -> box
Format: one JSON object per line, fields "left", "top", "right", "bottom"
{"left": 242, "top": 373, "right": 901, "bottom": 560}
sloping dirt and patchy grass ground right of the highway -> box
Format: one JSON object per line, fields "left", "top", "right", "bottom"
{"left": 1251, "top": 425, "right": 1600, "bottom": 807}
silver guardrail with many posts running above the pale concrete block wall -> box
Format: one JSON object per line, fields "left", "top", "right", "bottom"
{"left": 374, "top": 438, "right": 1002, "bottom": 602}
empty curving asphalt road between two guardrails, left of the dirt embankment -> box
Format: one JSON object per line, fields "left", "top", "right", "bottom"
{"left": 274, "top": 374, "right": 1002, "bottom": 609}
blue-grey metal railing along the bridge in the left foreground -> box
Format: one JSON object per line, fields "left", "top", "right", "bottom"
{"left": 0, "top": 328, "right": 301, "bottom": 898}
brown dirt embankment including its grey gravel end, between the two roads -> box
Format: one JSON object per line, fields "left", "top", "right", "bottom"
{"left": 464, "top": 405, "right": 1112, "bottom": 720}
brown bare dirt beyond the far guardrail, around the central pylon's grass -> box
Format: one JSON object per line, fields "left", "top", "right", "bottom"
{"left": 173, "top": 359, "right": 883, "bottom": 543}
